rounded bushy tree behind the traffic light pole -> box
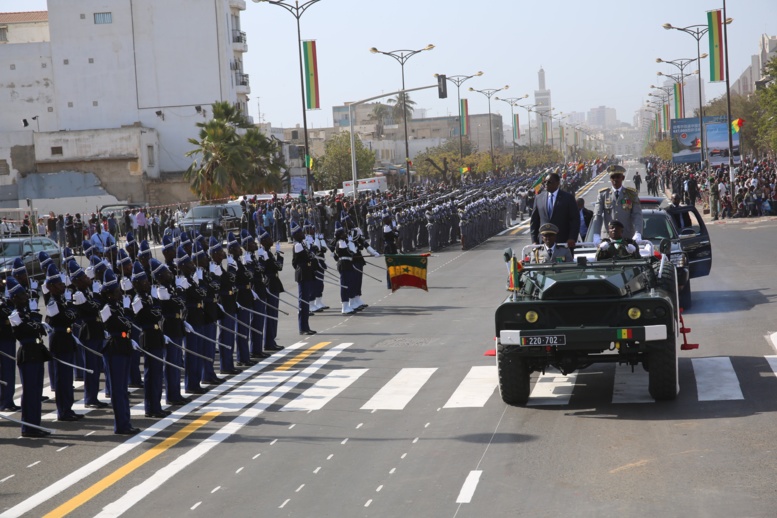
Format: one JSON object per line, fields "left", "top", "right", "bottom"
{"left": 314, "top": 131, "right": 375, "bottom": 190}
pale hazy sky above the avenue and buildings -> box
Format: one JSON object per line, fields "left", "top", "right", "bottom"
{"left": 6, "top": 0, "right": 777, "bottom": 128}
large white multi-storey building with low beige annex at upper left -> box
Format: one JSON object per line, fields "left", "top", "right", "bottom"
{"left": 0, "top": 0, "right": 250, "bottom": 211}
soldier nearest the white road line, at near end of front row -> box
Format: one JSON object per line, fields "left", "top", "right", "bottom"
{"left": 100, "top": 268, "right": 140, "bottom": 435}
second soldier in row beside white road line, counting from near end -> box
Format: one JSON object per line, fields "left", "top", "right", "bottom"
{"left": 132, "top": 261, "right": 170, "bottom": 418}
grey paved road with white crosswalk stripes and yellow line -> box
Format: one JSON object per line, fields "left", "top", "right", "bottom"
{"left": 0, "top": 176, "right": 777, "bottom": 517}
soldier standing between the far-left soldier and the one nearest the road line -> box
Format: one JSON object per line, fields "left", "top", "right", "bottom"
{"left": 46, "top": 264, "right": 83, "bottom": 421}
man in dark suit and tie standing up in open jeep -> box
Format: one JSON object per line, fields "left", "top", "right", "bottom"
{"left": 530, "top": 173, "right": 580, "bottom": 250}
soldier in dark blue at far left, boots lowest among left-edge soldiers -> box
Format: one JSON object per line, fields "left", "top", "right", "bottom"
{"left": 6, "top": 277, "right": 51, "bottom": 437}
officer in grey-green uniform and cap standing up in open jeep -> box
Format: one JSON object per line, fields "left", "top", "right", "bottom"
{"left": 593, "top": 165, "right": 642, "bottom": 246}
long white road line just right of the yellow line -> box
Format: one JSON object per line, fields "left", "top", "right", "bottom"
{"left": 97, "top": 343, "right": 353, "bottom": 518}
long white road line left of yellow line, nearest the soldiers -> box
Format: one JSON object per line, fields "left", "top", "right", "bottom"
{"left": 0, "top": 342, "right": 306, "bottom": 518}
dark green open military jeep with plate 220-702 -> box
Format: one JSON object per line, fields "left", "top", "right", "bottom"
{"left": 495, "top": 246, "right": 681, "bottom": 405}
